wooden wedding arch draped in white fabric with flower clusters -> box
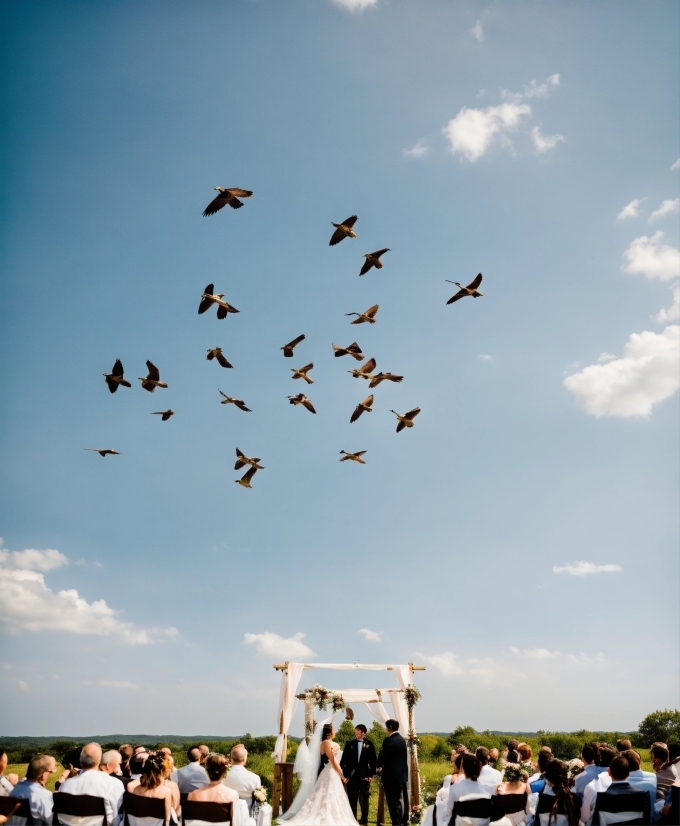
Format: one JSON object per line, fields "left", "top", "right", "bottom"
{"left": 272, "top": 662, "right": 426, "bottom": 816}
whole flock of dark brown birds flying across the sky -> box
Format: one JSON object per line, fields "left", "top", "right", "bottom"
{"left": 85, "top": 186, "right": 483, "bottom": 488}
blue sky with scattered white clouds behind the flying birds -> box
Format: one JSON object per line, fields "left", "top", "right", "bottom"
{"left": 0, "top": 0, "right": 680, "bottom": 736}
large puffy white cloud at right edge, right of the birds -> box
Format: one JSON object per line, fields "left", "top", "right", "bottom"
{"left": 562, "top": 324, "right": 680, "bottom": 418}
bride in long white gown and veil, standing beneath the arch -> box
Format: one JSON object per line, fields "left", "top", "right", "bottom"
{"left": 279, "top": 717, "right": 356, "bottom": 826}
